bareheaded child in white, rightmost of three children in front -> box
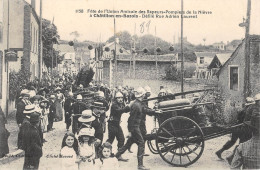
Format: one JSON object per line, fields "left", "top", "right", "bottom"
{"left": 96, "top": 142, "right": 119, "bottom": 170}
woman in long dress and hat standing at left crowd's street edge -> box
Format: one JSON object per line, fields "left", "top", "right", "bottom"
{"left": 55, "top": 87, "right": 65, "bottom": 122}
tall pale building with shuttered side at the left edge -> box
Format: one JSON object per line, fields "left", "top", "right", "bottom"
{"left": 0, "top": 0, "right": 40, "bottom": 115}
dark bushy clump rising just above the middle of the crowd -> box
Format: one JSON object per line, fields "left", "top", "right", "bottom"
{"left": 75, "top": 66, "right": 95, "bottom": 88}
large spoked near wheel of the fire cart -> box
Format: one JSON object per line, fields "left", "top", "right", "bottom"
{"left": 156, "top": 116, "right": 204, "bottom": 167}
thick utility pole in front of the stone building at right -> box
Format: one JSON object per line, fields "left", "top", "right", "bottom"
{"left": 244, "top": 0, "right": 251, "bottom": 100}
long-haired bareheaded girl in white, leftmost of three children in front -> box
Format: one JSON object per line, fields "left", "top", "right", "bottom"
{"left": 60, "top": 132, "right": 79, "bottom": 170}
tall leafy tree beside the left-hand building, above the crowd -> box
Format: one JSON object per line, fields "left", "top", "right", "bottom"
{"left": 42, "top": 19, "right": 63, "bottom": 68}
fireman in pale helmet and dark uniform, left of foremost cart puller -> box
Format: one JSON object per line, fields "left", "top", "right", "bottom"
{"left": 107, "top": 92, "right": 130, "bottom": 161}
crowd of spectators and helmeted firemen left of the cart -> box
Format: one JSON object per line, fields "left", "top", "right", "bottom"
{"left": 8, "top": 79, "right": 160, "bottom": 169}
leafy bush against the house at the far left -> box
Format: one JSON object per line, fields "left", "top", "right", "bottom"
{"left": 9, "top": 69, "right": 31, "bottom": 101}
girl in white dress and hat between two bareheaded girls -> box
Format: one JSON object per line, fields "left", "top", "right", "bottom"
{"left": 78, "top": 127, "right": 96, "bottom": 170}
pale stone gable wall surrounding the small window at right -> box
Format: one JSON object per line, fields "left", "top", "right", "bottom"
{"left": 218, "top": 42, "right": 245, "bottom": 122}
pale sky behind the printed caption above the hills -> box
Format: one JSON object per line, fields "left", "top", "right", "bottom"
{"left": 26, "top": 0, "right": 260, "bottom": 45}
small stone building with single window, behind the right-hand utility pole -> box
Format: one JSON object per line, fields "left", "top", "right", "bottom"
{"left": 217, "top": 35, "right": 260, "bottom": 122}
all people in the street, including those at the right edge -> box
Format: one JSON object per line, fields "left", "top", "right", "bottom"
{"left": 0, "top": 77, "right": 260, "bottom": 170}
